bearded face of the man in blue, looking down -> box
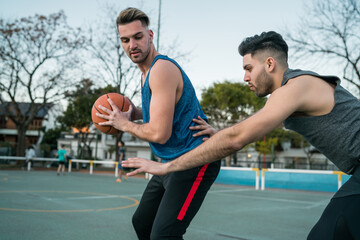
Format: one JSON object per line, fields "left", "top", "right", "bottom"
{"left": 118, "top": 20, "right": 153, "bottom": 63}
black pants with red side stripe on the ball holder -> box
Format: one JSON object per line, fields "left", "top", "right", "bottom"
{"left": 132, "top": 161, "right": 220, "bottom": 240}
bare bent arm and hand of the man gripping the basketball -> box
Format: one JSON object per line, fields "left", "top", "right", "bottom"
{"left": 98, "top": 61, "right": 182, "bottom": 144}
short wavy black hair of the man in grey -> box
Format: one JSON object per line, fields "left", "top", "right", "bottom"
{"left": 238, "top": 31, "right": 289, "bottom": 64}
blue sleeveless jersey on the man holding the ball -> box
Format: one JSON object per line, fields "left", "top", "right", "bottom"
{"left": 141, "top": 55, "right": 207, "bottom": 161}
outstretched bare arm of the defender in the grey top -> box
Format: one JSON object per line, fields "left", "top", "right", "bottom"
{"left": 124, "top": 83, "right": 302, "bottom": 175}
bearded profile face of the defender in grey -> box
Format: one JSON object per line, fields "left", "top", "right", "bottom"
{"left": 243, "top": 54, "right": 274, "bottom": 97}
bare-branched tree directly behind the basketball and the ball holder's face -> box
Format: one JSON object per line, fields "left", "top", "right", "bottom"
{"left": 86, "top": 6, "right": 141, "bottom": 163}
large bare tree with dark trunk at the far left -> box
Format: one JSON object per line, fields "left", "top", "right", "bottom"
{"left": 0, "top": 11, "right": 83, "bottom": 156}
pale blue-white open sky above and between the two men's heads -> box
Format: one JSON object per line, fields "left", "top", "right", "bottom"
{"left": 0, "top": 0, "right": 322, "bottom": 97}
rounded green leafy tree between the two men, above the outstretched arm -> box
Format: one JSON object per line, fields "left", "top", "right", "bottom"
{"left": 201, "top": 81, "right": 266, "bottom": 126}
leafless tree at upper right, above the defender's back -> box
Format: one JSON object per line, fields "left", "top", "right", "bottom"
{"left": 287, "top": 0, "right": 360, "bottom": 98}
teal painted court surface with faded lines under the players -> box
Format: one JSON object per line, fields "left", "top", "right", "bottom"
{"left": 0, "top": 170, "right": 333, "bottom": 240}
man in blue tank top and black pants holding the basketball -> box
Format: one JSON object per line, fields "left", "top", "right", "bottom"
{"left": 99, "top": 8, "right": 220, "bottom": 239}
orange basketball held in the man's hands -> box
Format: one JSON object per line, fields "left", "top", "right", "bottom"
{"left": 91, "top": 93, "right": 130, "bottom": 135}
